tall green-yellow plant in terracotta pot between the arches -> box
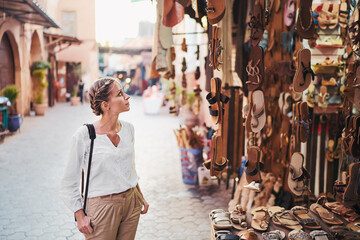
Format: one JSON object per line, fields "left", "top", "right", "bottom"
{"left": 30, "top": 61, "right": 51, "bottom": 115}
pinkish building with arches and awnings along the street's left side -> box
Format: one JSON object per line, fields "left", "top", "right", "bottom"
{"left": 0, "top": 0, "right": 98, "bottom": 115}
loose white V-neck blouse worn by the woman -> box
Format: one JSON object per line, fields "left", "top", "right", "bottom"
{"left": 60, "top": 120, "right": 138, "bottom": 212}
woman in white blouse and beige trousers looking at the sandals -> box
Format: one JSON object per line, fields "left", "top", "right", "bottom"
{"left": 60, "top": 77, "right": 149, "bottom": 240}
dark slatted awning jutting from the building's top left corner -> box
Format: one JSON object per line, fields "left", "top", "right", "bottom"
{"left": 0, "top": 0, "right": 60, "bottom": 28}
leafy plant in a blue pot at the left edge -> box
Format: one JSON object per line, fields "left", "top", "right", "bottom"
{"left": 2, "top": 85, "right": 22, "bottom": 132}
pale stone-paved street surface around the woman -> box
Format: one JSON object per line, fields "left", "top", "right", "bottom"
{"left": 0, "top": 97, "right": 231, "bottom": 240}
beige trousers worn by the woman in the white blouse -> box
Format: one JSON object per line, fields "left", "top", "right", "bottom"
{"left": 85, "top": 187, "right": 142, "bottom": 240}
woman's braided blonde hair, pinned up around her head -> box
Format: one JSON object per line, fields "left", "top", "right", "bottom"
{"left": 89, "top": 77, "right": 118, "bottom": 116}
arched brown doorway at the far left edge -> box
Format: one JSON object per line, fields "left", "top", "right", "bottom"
{"left": 0, "top": 33, "right": 15, "bottom": 90}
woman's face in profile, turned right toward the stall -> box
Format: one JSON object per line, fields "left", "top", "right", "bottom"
{"left": 107, "top": 82, "right": 130, "bottom": 114}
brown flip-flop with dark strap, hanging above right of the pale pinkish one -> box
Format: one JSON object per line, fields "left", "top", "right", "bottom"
{"left": 293, "top": 49, "right": 314, "bottom": 92}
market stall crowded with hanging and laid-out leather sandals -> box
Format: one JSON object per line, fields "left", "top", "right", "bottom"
{"left": 152, "top": 0, "right": 360, "bottom": 239}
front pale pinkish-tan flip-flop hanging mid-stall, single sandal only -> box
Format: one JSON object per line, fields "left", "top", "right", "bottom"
{"left": 250, "top": 90, "right": 266, "bottom": 133}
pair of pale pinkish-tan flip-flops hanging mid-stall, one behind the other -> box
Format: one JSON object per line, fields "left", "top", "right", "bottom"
{"left": 245, "top": 90, "right": 266, "bottom": 133}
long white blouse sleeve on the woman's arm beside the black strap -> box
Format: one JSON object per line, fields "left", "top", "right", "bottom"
{"left": 59, "top": 129, "right": 85, "bottom": 212}
